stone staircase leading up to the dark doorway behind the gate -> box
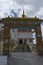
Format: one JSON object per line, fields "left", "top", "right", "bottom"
{"left": 14, "top": 43, "right": 31, "bottom": 52}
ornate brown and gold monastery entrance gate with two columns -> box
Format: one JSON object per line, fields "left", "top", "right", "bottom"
{"left": 0, "top": 17, "right": 43, "bottom": 55}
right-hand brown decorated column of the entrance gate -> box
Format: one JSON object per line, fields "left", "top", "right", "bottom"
{"left": 36, "top": 24, "right": 43, "bottom": 56}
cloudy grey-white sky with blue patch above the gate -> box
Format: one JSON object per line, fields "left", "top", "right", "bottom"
{"left": 0, "top": 0, "right": 43, "bottom": 44}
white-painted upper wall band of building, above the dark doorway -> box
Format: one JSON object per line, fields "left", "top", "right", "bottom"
{"left": 14, "top": 32, "right": 33, "bottom": 38}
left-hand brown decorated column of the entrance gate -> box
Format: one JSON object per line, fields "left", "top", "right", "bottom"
{"left": 3, "top": 25, "right": 10, "bottom": 56}
